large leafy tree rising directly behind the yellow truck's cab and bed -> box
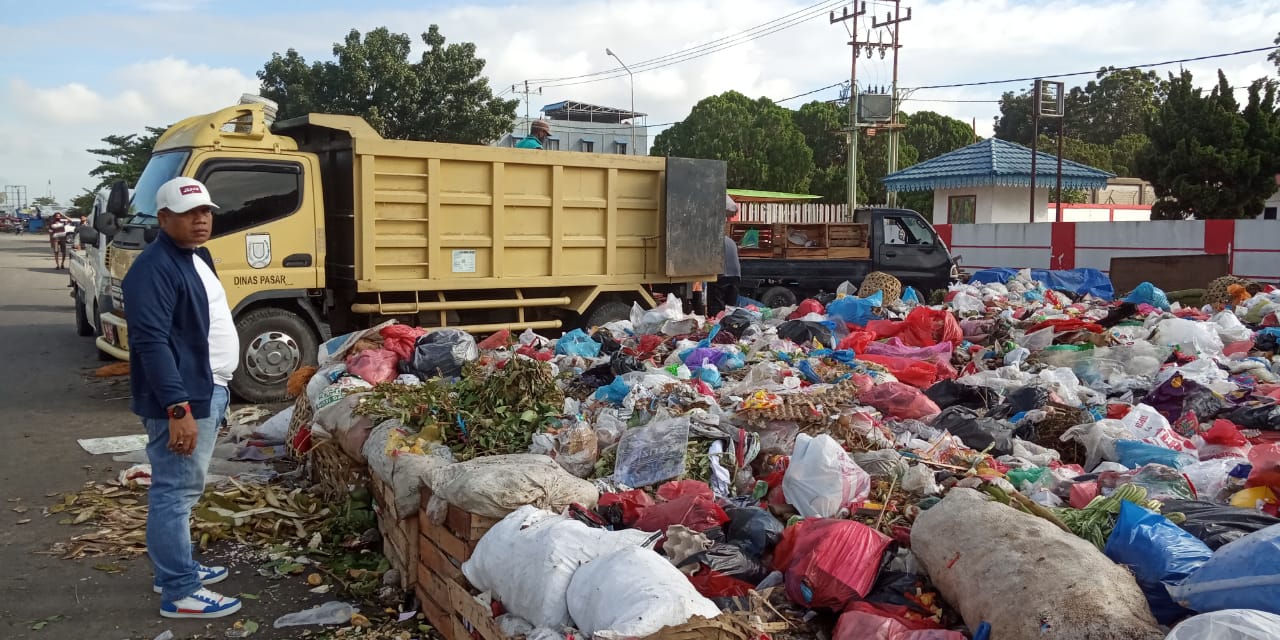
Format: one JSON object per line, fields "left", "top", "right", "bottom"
{"left": 257, "top": 24, "right": 518, "bottom": 145}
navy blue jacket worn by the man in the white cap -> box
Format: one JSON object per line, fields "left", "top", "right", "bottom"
{"left": 120, "top": 232, "right": 214, "bottom": 419}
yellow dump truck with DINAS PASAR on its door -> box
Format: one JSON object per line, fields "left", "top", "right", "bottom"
{"left": 97, "top": 104, "right": 724, "bottom": 402}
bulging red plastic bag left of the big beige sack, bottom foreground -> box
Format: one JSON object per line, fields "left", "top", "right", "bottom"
{"left": 773, "top": 518, "right": 892, "bottom": 611}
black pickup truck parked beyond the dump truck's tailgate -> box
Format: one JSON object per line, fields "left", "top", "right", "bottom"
{"left": 740, "top": 209, "right": 959, "bottom": 307}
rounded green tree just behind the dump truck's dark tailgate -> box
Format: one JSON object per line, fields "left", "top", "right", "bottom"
{"left": 652, "top": 91, "right": 813, "bottom": 193}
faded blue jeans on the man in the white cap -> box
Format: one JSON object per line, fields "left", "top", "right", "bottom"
{"left": 142, "top": 385, "right": 230, "bottom": 602}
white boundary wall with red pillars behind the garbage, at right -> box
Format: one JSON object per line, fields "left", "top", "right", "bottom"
{"left": 934, "top": 220, "right": 1280, "bottom": 284}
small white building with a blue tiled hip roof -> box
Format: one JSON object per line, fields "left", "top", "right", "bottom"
{"left": 883, "top": 138, "right": 1115, "bottom": 224}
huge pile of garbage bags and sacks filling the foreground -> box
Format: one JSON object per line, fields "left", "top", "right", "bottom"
{"left": 289, "top": 271, "right": 1280, "bottom": 640}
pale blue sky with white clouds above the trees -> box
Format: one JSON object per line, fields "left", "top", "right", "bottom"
{"left": 0, "top": 0, "right": 1280, "bottom": 200}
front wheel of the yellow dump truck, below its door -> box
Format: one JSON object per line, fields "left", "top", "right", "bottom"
{"left": 230, "top": 307, "right": 320, "bottom": 403}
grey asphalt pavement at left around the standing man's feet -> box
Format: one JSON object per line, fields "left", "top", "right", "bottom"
{"left": 0, "top": 234, "right": 334, "bottom": 640}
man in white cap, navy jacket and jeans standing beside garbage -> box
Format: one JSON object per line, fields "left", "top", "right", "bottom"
{"left": 123, "top": 178, "right": 241, "bottom": 618}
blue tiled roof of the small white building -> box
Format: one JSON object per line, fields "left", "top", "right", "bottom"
{"left": 883, "top": 138, "right": 1115, "bottom": 191}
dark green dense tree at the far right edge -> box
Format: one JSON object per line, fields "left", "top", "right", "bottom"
{"left": 1137, "top": 70, "right": 1280, "bottom": 220}
